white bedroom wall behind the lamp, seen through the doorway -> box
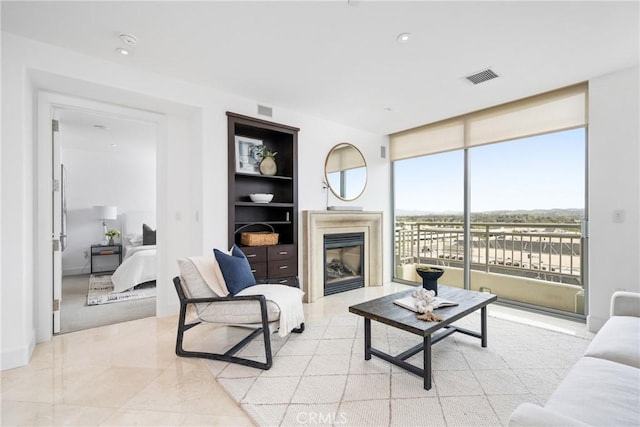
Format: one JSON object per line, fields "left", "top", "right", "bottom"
{"left": 61, "top": 145, "right": 156, "bottom": 275}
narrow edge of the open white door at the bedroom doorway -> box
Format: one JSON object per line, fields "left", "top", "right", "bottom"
{"left": 51, "top": 117, "right": 66, "bottom": 334}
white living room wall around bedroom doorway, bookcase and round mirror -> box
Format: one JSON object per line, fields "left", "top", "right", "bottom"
{"left": 0, "top": 33, "right": 390, "bottom": 369}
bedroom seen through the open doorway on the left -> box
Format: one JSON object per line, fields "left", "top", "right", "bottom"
{"left": 57, "top": 108, "right": 157, "bottom": 333}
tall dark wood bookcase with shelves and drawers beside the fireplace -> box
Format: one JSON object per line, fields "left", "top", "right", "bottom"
{"left": 227, "top": 112, "right": 299, "bottom": 286}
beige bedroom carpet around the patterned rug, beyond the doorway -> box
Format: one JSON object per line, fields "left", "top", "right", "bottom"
{"left": 60, "top": 274, "right": 156, "bottom": 333}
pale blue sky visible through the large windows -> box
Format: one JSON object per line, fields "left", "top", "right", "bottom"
{"left": 394, "top": 128, "right": 586, "bottom": 212}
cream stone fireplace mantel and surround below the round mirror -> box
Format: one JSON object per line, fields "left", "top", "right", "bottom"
{"left": 302, "top": 211, "right": 382, "bottom": 302}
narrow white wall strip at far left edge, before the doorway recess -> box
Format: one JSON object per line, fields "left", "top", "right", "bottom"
{"left": 0, "top": 34, "right": 35, "bottom": 367}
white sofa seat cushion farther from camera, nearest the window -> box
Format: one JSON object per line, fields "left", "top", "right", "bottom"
{"left": 585, "top": 316, "right": 640, "bottom": 368}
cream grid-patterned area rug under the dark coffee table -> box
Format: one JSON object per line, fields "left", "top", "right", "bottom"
{"left": 207, "top": 313, "right": 589, "bottom": 426}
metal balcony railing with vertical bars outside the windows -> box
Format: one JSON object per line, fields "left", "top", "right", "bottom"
{"left": 395, "top": 222, "right": 583, "bottom": 286}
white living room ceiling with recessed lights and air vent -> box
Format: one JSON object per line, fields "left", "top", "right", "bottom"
{"left": 2, "top": 0, "right": 640, "bottom": 134}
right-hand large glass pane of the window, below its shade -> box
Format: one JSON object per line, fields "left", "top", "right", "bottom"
{"left": 468, "top": 128, "right": 585, "bottom": 314}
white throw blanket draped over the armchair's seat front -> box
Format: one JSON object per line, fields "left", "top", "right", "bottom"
{"left": 236, "top": 285, "right": 304, "bottom": 337}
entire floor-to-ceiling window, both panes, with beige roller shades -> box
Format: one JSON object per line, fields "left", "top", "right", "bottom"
{"left": 392, "top": 83, "right": 587, "bottom": 316}
